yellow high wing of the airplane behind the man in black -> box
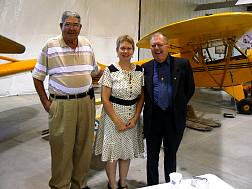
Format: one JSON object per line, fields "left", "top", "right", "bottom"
{"left": 137, "top": 12, "right": 252, "bottom": 54}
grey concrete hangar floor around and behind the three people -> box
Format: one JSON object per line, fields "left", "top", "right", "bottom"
{"left": 0, "top": 89, "right": 252, "bottom": 189}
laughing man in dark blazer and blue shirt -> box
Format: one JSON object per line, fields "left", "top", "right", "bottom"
{"left": 143, "top": 33, "right": 195, "bottom": 186}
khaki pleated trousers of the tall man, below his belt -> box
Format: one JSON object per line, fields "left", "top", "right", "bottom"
{"left": 49, "top": 96, "right": 95, "bottom": 189}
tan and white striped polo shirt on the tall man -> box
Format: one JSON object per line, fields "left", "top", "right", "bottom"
{"left": 32, "top": 35, "right": 98, "bottom": 95}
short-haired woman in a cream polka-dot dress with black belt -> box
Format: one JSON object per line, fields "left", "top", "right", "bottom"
{"left": 95, "top": 35, "right": 144, "bottom": 189}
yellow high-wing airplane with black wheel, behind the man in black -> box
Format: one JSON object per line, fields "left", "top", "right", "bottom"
{"left": 137, "top": 12, "right": 252, "bottom": 114}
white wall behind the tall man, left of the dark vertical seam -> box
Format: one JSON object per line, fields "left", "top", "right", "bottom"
{"left": 0, "top": 0, "right": 139, "bottom": 96}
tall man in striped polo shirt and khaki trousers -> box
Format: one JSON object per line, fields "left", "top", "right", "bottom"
{"left": 33, "top": 11, "right": 98, "bottom": 189}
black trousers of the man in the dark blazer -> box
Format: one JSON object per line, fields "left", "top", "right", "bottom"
{"left": 146, "top": 106, "right": 183, "bottom": 186}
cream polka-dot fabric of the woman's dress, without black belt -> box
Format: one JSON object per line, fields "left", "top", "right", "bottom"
{"left": 95, "top": 64, "right": 144, "bottom": 161}
